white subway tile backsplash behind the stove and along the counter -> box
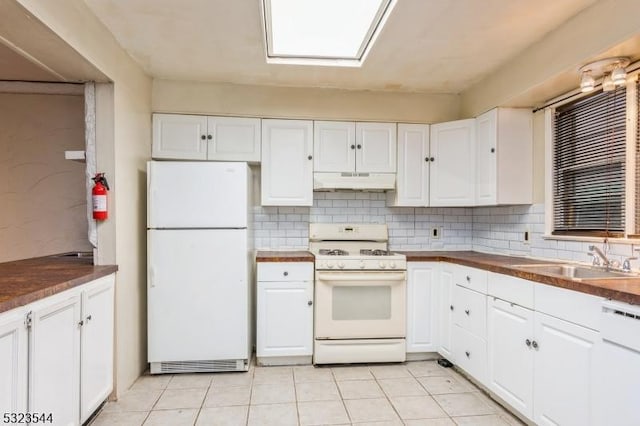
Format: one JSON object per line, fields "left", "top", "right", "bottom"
{"left": 254, "top": 195, "right": 640, "bottom": 268}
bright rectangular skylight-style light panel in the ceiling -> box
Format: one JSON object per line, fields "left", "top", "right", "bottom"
{"left": 263, "top": 0, "right": 397, "bottom": 67}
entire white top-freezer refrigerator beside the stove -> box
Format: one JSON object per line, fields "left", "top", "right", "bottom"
{"left": 147, "top": 161, "right": 254, "bottom": 374}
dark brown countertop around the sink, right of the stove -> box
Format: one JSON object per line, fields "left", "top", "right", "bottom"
{"left": 399, "top": 251, "right": 640, "bottom": 305}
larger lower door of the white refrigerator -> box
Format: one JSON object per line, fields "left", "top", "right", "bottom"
{"left": 147, "top": 229, "right": 251, "bottom": 362}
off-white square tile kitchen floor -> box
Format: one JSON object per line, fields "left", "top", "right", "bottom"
{"left": 87, "top": 361, "right": 522, "bottom": 426}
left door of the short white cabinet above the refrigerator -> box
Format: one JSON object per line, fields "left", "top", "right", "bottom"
{"left": 151, "top": 114, "right": 208, "bottom": 160}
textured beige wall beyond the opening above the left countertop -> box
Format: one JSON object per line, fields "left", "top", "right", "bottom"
{"left": 0, "top": 93, "right": 92, "bottom": 262}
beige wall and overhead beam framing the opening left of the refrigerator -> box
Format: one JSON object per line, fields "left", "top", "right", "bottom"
{"left": 12, "top": 0, "right": 151, "bottom": 393}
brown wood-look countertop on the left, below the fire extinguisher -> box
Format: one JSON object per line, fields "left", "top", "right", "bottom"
{"left": 0, "top": 256, "right": 118, "bottom": 313}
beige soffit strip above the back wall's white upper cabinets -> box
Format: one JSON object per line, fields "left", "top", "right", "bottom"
{"left": 152, "top": 79, "right": 460, "bottom": 123}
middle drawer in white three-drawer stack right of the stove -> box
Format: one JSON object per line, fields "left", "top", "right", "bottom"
{"left": 453, "top": 285, "right": 487, "bottom": 339}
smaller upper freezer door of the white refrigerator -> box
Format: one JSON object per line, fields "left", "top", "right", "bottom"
{"left": 147, "top": 161, "right": 250, "bottom": 228}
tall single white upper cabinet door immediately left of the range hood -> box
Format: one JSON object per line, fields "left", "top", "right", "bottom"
{"left": 261, "top": 120, "right": 313, "bottom": 206}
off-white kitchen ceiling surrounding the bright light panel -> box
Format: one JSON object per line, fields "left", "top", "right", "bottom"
{"left": 85, "top": 0, "right": 595, "bottom": 93}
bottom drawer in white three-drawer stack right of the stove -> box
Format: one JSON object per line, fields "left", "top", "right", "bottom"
{"left": 453, "top": 325, "right": 488, "bottom": 384}
